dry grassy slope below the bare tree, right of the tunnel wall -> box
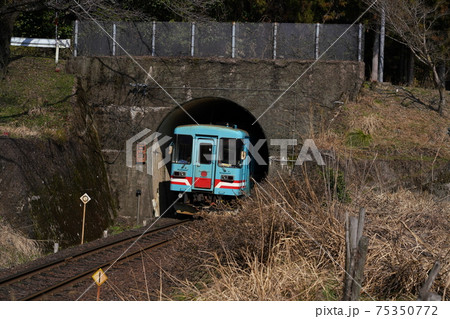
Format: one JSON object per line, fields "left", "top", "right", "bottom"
{"left": 333, "top": 85, "right": 450, "bottom": 158}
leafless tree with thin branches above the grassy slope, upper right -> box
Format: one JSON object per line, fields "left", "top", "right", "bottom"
{"left": 365, "top": 0, "right": 450, "bottom": 114}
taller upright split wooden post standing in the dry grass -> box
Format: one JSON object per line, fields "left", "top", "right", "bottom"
{"left": 342, "top": 208, "right": 369, "bottom": 301}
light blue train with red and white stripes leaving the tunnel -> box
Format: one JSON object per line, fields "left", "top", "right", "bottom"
{"left": 170, "top": 125, "right": 252, "bottom": 203}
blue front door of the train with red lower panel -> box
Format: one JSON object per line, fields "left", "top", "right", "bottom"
{"left": 192, "top": 138, "right": 216, "bottom": 191}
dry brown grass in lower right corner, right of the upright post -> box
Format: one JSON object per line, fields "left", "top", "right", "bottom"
{"left": 366, "top": 190, "right": 450, "bottom": 300}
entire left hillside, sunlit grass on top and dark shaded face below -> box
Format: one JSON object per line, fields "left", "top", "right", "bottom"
{"left": 0, "top": 57, "right": 115, "bottom": 258}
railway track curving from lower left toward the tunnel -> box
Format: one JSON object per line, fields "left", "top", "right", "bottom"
{"left": 0, "top": 220, "right": 187, "bottom": 300}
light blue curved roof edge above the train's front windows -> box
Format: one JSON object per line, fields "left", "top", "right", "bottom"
{"left": 174, "top": 124, "right": 249, "bottom": 138}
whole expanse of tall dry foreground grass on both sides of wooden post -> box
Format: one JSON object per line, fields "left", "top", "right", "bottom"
{"left": 173, "top": 170, "right": 450, "bottom": 300}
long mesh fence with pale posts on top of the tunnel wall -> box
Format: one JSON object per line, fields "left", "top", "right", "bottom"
{"left": 73, "top": 21, "right": 364, "bottom": 61}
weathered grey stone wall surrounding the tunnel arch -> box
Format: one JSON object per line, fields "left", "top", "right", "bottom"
{"left": 67, "top": 57, "right": 364, "bottom": 217}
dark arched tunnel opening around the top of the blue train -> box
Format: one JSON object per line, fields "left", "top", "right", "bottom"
{"left": 157, "top": 97, "right": 269, "bottom": 182}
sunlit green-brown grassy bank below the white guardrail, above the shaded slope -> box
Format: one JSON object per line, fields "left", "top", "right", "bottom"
{"left": 0, "top": 57, "right": 75, "bottom": 139}
